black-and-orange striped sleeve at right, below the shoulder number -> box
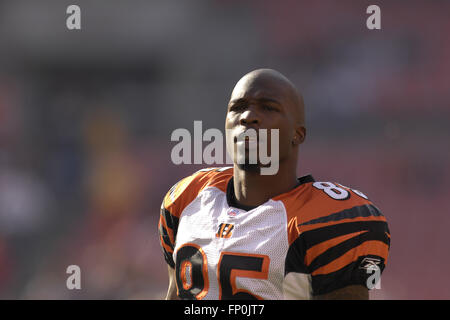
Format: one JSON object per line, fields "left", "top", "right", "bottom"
{"left": 286, "top": 203, "right": 390, "bottom": 295}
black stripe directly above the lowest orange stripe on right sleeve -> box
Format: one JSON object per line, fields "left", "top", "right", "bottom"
{"left": 308, "top": 231, "right": 390, "bottom": 273}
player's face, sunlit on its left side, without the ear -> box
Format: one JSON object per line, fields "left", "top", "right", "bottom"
{"left": 225, "top": 77, "right": 295, "bottom": 171}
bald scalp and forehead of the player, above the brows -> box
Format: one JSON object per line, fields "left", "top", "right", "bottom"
{"left": 230, "top": 69, "right": 305, "bottom": 126}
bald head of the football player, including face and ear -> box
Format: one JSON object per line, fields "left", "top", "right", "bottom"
{"left": 225, "top": 69, "right": 306, "bottom": 172}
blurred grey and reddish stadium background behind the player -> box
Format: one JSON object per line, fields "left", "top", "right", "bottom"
{"left": 0, "top": 0, "right": 450, "bottom": 299}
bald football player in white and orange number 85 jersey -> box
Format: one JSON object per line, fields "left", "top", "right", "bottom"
{"left": 158, "top": 69, "right": 390, "bottom": 299}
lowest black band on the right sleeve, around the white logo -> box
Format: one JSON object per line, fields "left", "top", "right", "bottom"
{"left": 311, "top": 255, "right": 385, "bottom": 295}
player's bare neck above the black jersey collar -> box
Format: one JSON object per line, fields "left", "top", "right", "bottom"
{"left": 233, "top": 165, "right": 298, "bottom": 206}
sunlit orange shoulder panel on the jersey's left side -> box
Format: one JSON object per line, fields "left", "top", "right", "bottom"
{"left": 163, "top": 167, "right": 233, "bottom": 218}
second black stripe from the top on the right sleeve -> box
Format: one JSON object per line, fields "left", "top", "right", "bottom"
{"left": 295, "top": 220, "right": 389, "bottom": 252}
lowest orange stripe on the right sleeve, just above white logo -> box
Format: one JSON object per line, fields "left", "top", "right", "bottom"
{"left": 311, "top": 240, "right": 389, "bottom": 276}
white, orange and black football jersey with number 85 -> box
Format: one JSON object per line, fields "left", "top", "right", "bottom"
{"left": 158, "top": 167, "right": 390, "bottom": 299}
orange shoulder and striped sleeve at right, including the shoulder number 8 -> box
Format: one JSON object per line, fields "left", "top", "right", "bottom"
{"left": 286, "top": 181, "right": 390, "bottom": 294}
